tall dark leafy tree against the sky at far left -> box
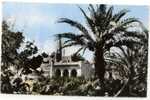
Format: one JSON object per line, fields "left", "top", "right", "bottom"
{"left": 1, "top": 21, "right": 24, "bottom": 71}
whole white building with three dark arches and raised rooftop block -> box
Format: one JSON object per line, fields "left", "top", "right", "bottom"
{"left": 41, "top": 57, "right": 94, "bottom": 78}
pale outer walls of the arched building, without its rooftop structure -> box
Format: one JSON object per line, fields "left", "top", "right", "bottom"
{"left": 41, "top": 57, "right": 94, "bottom": 79}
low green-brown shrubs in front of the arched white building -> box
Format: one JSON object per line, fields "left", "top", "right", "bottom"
{"left": 29, "top": 77, "right": 102, "bottom": 96}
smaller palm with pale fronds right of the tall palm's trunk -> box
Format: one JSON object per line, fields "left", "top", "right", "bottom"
{"left": 105, "top": 46, "right": 138, "bottom": 96}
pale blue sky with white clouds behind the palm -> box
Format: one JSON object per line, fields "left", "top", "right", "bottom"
{"left": 2, "top": 2, "right": 149, "bottom": 60}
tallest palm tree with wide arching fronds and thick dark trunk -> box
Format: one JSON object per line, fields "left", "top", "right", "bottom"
{"left": 56, "top": 4, "right": 145, "bottom": 82}
